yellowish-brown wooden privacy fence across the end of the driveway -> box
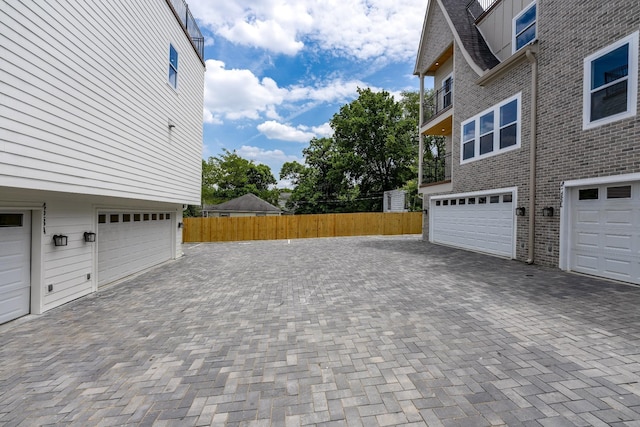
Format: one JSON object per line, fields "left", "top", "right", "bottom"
{"left": 182, "top": 212, "right": 422, "bottom": 243}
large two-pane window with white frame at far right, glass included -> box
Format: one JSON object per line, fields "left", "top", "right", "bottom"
{"left": 582, "top": 31, "right": 638, "bottom": 129}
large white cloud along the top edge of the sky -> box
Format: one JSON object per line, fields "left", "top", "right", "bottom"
{"left": 189, "top": 0, "right": 425, "bottom": 60}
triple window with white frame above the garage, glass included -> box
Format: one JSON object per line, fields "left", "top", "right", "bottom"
{"left": 460, "top": 93, "right": 521, "bottom": 164}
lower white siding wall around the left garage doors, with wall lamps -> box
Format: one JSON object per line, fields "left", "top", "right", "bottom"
{"left": 0, "top": 187, "right": 182, "bottom": 313}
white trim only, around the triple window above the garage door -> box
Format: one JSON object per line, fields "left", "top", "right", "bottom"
{"left": 460, "top": 92, "right": 522, "bottom": 165}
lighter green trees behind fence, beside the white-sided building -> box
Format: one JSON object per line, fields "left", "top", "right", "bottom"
{"left": 202, "top": 149, "right": 279, "bottom": 205}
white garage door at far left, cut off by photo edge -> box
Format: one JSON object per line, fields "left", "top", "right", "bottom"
{"left": 0, "top": 212, "right": 31, "bottom": 323}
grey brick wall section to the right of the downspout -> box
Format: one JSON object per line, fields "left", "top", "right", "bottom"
{"left": 535, "top": 0, "right": 640, "bottom": 266}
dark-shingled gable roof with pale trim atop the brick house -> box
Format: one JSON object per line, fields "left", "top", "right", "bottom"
{"left": 415, "top": 0, "right": 500, "bottom": 76}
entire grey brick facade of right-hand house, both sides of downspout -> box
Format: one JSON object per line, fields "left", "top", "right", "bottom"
{"left": 423, "top": 0, "right": 640, "bottom": 266}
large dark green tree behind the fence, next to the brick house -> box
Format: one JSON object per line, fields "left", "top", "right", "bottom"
{"left": 280, "top": 89, "right": 419, "bottom": 213}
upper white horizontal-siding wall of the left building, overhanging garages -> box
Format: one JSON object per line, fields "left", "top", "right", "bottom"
{"left": 0, "top": 0, "right": 204, "bottom": 204}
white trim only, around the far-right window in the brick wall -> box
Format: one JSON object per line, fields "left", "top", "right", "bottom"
{"left": 582, "top": 31, "right": 639, "bottom": 130}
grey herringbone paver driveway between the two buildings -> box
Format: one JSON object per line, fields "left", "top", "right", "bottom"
{"left": 0, "top": 236, "right": 640, "bottom": 426}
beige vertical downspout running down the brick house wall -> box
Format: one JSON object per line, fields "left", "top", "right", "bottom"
{"left": 526, "top": 49, "right": 538, "bottom": 264}
